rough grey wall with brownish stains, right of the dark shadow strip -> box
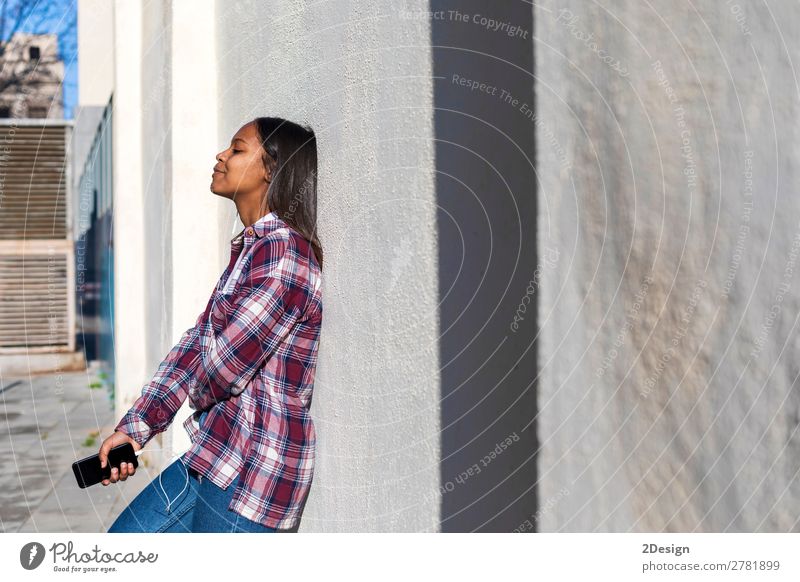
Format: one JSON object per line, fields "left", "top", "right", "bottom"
{"left": 534, "top": 0, "right": 800, "bottom": 532}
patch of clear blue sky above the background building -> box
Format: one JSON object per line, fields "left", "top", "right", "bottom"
{"left": 0, "top": 0, "right": 78, "bottom": 119}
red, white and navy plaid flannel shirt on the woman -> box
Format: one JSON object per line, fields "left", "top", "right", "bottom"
{"left": 116, "top": 212, "right": 322, "bottom": 529}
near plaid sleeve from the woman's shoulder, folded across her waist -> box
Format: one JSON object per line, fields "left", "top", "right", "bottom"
{"left": 189, "top": 235, "right": 308, "bottom": 410}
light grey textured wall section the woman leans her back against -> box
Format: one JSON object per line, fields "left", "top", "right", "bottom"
{"left": 217, "top": 1, "right": 440, "bottom": 531}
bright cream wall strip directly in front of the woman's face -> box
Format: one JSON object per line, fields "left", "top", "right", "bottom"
{"left": 167, "top": 0, "right": 225, "bottom": 451}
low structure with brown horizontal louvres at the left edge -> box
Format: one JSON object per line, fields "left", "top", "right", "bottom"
{"left": 0, "top": 119, "right": 77, "bottom": 374}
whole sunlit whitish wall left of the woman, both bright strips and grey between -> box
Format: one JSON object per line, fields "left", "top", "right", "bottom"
{"left": 114, "top": 0, "right": 225, "bottom": 468}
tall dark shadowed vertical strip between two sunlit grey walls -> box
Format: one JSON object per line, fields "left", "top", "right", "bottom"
{"left": 430, "top": 0, "right": 538, "bottom": 532}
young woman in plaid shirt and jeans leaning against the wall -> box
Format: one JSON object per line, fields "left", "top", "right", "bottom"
{"left": 100, "top": 117, "right": 322, "bottom": 532}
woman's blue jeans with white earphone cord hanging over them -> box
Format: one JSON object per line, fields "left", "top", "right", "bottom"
{"left": 108, "top": 412, "right": 276, "bottom": 533}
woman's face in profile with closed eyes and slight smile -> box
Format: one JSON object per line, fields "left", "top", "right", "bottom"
{"left": 211, "top": 122, "right": 271, "bottom": 201}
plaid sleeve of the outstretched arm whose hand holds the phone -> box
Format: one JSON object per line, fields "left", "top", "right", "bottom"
{"left": 114, "top": 308, "right": 208, "bottom": 447}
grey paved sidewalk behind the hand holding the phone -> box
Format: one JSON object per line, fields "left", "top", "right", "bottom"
{"left": 0, "top": 370, "right": 158, "bottom": 532}
